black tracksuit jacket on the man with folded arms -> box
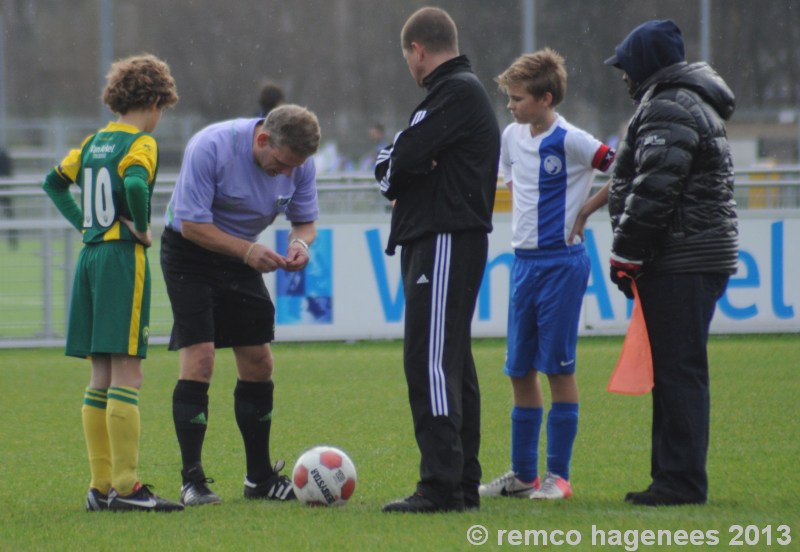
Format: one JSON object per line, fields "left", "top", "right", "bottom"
{"left": 375, "top": 56, "right": 500, "bottom": 255}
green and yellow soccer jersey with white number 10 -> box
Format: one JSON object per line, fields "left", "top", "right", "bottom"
{"left": 56, "top": 122, "right": 158, "bottom": 243}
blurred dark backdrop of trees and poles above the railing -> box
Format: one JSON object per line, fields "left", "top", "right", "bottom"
{"left": 0, "top": 0, "right": 800, "bottom": 172}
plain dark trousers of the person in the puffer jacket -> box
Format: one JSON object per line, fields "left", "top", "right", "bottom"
{"left": 637, "top": 274, "right": 728, "bottom": 501}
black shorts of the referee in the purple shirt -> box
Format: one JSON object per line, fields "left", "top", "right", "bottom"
{"left": 161, "top": 228, "right": 275, "bottom": 351}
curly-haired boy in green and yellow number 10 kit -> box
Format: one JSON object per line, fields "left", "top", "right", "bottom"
{"left": 43, "top": 55, "right": 183, "bottom": 511}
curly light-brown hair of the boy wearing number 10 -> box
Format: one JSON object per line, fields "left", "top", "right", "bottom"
{"left": 103, "top": 54, "right": 178, "bottom": 115}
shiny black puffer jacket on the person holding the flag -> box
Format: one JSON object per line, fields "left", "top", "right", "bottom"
{"left": 609, "top": 62, "right": 738, "bottom": 274}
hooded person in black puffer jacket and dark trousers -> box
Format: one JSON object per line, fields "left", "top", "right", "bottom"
{"left": 605, "top": 20, "right": 738, "bottom": 506}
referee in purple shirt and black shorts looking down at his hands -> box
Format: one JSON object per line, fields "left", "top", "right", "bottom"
{"left": 161, "top": 105, "right": 320, "bottom": 506}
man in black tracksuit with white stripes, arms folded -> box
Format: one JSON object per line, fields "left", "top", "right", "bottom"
{"left": 375, "top": 8, "right": 500, "bottom": 512}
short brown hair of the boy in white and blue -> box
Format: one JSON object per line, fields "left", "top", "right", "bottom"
{"left": 494, "top": 48, "right": 567, "bottom": 107}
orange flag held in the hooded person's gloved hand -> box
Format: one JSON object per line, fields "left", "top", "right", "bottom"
{"left": 606, "top": 280, "right": 653, "bottom": 395}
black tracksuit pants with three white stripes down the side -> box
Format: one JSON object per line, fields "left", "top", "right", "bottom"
{"left": 401, "top": 232, "right": 488, "bottom": 507}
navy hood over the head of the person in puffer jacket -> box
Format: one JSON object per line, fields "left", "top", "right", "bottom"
{"left": 605, "top": 19, "right": 685, "bottom": 84}
